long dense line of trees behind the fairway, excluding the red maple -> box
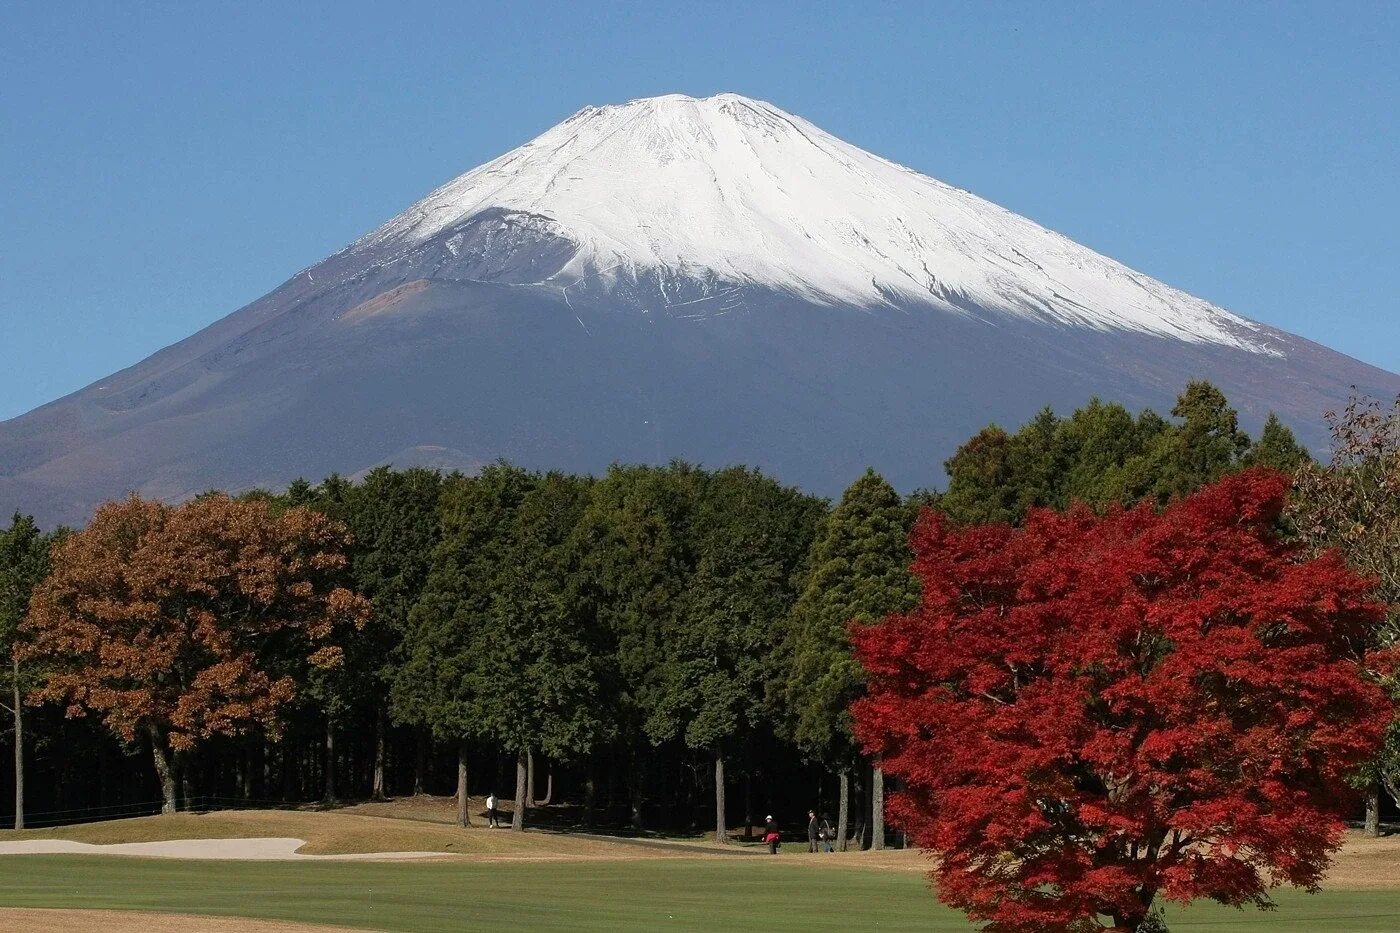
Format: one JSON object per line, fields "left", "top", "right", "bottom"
{"left": 0, "top": 382, "right": 1400, "bottom": 848}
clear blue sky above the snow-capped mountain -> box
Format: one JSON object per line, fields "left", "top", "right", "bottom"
{"left": 0, "top": 0, "right": 1400, "bottom": 417}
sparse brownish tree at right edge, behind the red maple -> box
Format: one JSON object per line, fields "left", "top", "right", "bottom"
{"left": 1289, "top": 396, "right": 1400, "bottom": 835}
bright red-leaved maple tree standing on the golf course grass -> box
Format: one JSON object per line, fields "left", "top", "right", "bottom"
{"left": 853, "top": 471, "right": 1389, "bottom": 933}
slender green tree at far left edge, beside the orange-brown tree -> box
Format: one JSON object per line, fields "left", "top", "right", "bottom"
{"left": 0, "top": 513, "right": 52, "bottom": 829}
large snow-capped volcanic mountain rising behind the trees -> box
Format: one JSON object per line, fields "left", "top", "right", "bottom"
{"left": 0, "top": 94, "right": 1400, "bottom": 523}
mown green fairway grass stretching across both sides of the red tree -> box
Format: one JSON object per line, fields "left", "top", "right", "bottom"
{"left": 0, "top": 856, "right": 1400, "bottom": 933}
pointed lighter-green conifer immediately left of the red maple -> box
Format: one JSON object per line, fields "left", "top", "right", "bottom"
{"left": 781, "top": 469, "right": 918, "bottom": 848}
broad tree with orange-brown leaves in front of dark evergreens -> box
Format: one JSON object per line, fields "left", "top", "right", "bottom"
{"left": 22, "top": 495, "right": 370, "bottom": 813}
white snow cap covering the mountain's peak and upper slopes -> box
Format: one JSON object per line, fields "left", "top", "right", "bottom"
{"left": 351, "top": 94, "right": 1275, "bottom": 353}
